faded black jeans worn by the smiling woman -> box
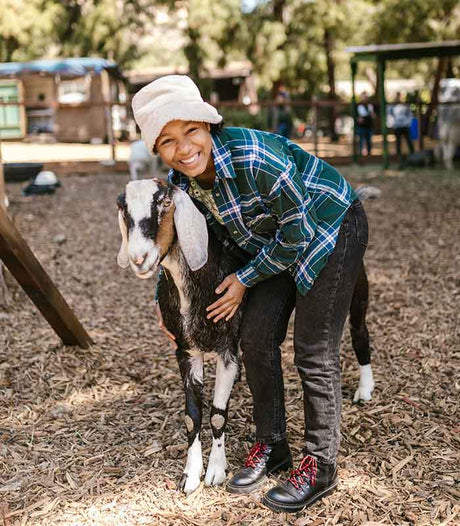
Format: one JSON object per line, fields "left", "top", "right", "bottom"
{"left": 241, "top": 200, "right": 368, "bottom": 463}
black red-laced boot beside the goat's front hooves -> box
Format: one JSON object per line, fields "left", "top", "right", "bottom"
{"left": 227, "top": 440, "right": 292, "bottom": 493}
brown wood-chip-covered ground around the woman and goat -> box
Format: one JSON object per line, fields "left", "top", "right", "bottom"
{"left": 0, "top": 168, "right": 460, "bottom": 526}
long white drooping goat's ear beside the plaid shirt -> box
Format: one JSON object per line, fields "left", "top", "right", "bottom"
{"left": 174, "top": 190, "right": 208, "bottom": 270}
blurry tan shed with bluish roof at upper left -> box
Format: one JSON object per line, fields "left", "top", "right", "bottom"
{"left": 0, "top": 57, "right": 128, "bottom": 142}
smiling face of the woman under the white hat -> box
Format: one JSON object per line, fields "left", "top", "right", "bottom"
{"left": 155, "top": 121, "right": 214, "bottom": 177}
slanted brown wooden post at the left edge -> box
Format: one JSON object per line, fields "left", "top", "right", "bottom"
{"left": 0, "top": 207, "right": 92, "bottom": 349}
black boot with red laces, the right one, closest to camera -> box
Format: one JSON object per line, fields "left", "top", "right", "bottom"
{"left": 262, "top": 455, "right": 338, "bottom": 513}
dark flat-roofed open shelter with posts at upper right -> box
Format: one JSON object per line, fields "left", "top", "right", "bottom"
{"left": 346, "top": 40, "right": 460, "bottom": 168}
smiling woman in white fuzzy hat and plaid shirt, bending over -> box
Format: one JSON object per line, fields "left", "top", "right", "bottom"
{"left": 133, "top": 75, "right": 367, "bottom": 512}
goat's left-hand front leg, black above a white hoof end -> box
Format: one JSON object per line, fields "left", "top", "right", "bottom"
{"left": 176, "top": 350, "right": 203, "bottom": 495}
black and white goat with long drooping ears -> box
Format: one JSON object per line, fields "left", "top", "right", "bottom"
{"left": 118, "top": 179, "right": 374, "bottom": 493}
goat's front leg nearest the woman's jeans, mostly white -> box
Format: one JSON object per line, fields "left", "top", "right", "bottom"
{"left": 204, "top": 355, "right": 238, "bottom": 486}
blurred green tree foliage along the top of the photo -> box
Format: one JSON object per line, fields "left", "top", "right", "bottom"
{"left": 0, "top": 0, "right": 460, "bottom": 98}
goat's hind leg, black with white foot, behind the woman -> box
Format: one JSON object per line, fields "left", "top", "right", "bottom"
{"left": 350, "top": 262, "right": 374, "bottom": 402}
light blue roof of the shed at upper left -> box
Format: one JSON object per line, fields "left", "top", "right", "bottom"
{"left": 0, "top": 57, "right": 117, "bottom": 77}
